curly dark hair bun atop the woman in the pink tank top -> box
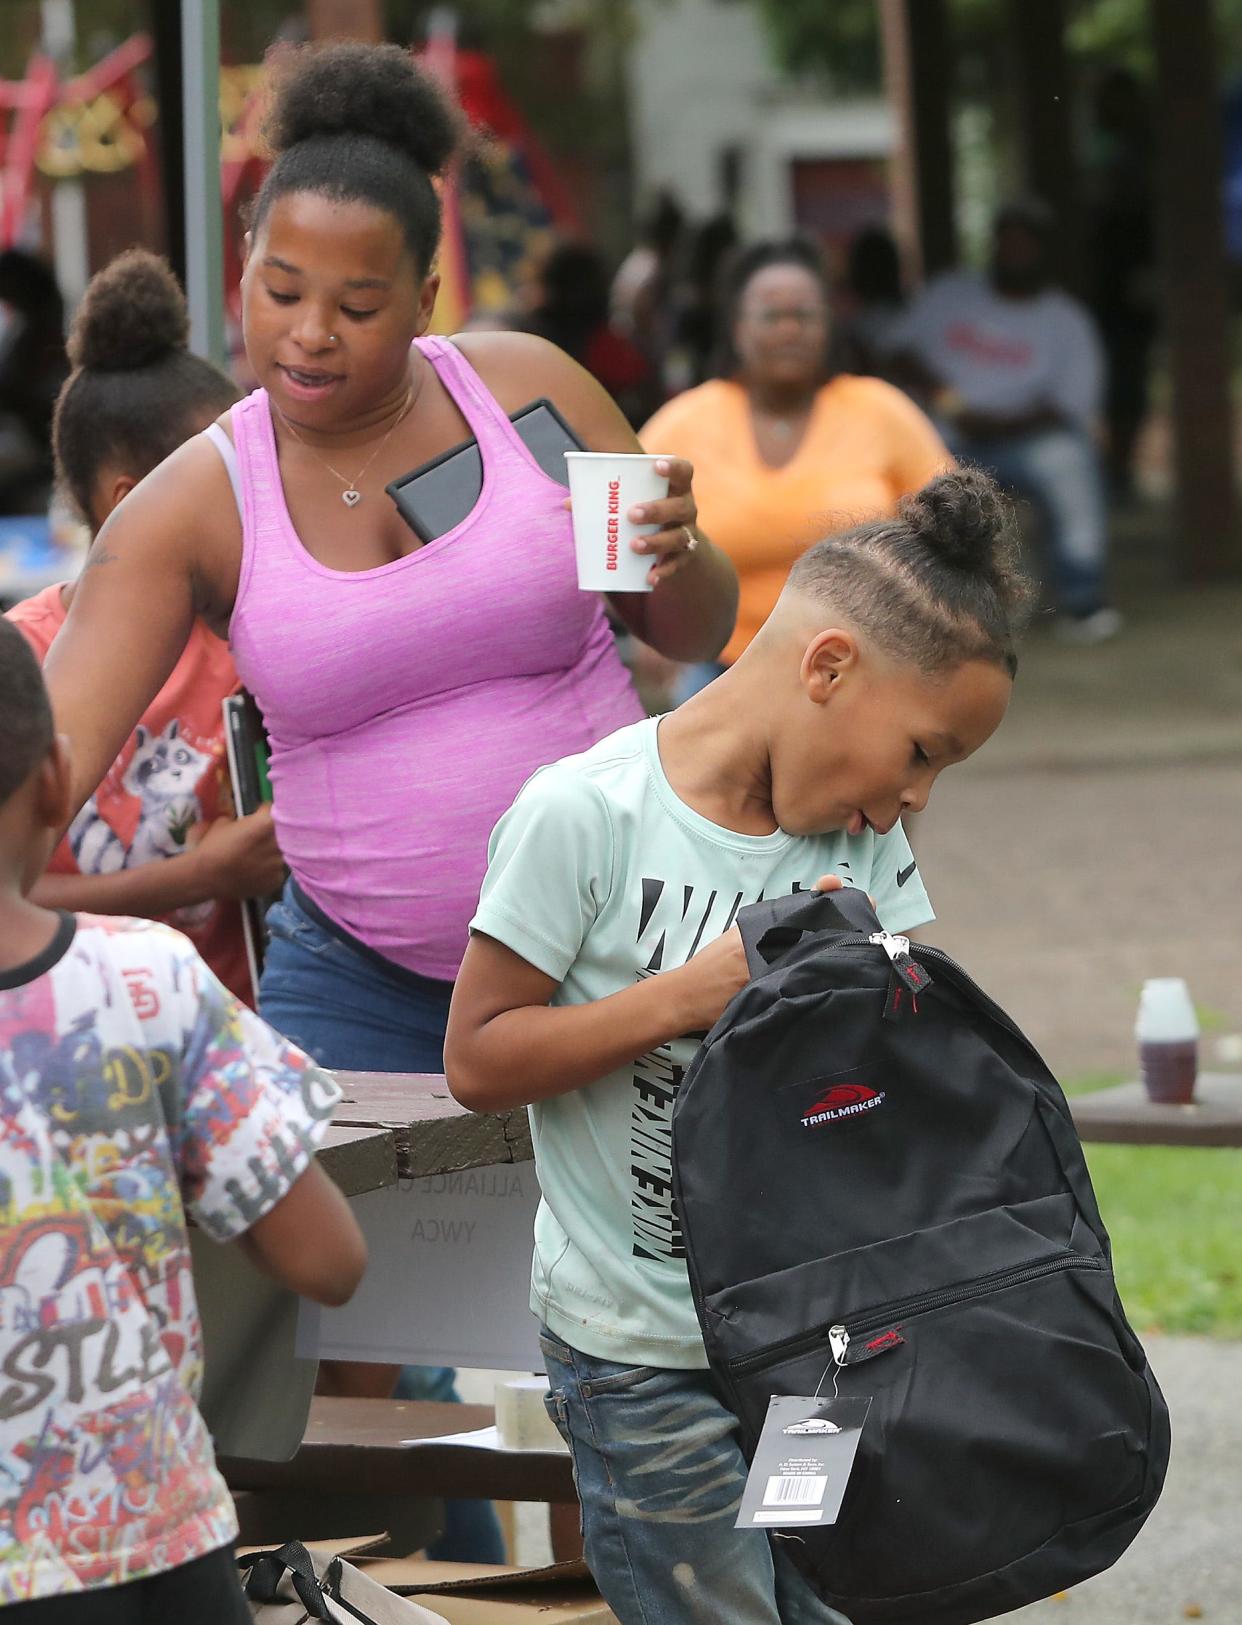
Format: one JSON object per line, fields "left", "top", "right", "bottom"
{"left": 263, "top": 41, "right": 460, "bottom": 176}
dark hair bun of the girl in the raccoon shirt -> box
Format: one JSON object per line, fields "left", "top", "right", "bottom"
{"left": 67, "top": 249, "right": 190, "bottom": 372}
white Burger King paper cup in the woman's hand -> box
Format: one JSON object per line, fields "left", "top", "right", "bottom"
{"left": 564, "top": 452, "right": 668, "bottom": 593}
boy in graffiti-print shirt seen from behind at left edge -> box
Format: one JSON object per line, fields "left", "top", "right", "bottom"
{"left": 0, "top": 619, "right": 366, "bottom": 1625}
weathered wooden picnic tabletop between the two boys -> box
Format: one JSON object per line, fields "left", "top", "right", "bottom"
{"left": 319, "top": 1073, "right": 535, "bottom": 1196}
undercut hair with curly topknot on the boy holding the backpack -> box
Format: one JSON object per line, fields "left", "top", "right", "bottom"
{"left": 788, "top": 468, "right": 1032, "bottom": 676}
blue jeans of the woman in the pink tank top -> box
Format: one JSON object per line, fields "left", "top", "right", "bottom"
{"left": 258, "top": 881, "right": 506, "bottom": 1563}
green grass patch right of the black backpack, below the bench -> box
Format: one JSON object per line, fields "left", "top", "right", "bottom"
{"left": 1066, "top": 1074, "right": 1242, "bottom": 1339}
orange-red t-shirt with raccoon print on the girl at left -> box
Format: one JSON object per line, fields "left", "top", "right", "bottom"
{"left": 7, "top": 585, "right": 254, "bottom": 1004}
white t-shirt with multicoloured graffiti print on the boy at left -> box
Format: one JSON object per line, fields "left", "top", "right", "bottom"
{"left": 0, "top": 915, "right": 340, "bottom": 1606}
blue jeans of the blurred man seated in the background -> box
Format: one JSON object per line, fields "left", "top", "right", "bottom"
{"left": 946, "top": 429, "right": 1109, "bottom": 616}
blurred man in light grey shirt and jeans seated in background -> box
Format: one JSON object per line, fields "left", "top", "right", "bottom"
{"left": 892, "top": 202, "right": 1122, "bottom": 644}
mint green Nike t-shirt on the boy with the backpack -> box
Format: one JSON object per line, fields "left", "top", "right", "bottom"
{"left": 471, "top": 718, "right": 932, "bottom": 1368}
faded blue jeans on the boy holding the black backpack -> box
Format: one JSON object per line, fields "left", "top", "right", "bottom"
{"left": 540, "top": 1329, "right": 847, "bottom": 1625}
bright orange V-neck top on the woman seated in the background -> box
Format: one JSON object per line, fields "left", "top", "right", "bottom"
{"left": 639, "top": 374, "right": 953, "bottom": 665}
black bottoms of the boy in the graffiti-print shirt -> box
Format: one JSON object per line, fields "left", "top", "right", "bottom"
{"left": 0, "top": 1545, "right": 252, "bottom": 1625}
